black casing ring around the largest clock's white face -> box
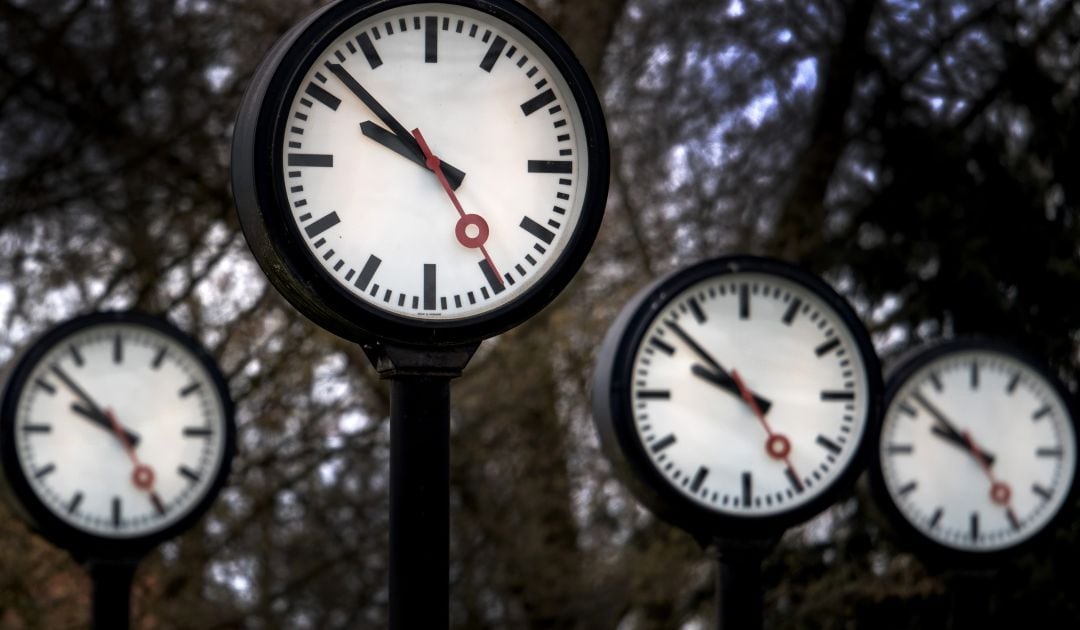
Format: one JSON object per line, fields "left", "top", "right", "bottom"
{"left": 232, "top": 0, "right": 610, "bottom": 346}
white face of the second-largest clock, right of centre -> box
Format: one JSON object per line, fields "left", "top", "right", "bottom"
{"left": 631, "top": 272, "right": 872, "bottom": 517}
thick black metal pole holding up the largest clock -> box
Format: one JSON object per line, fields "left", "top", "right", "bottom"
{"left": 390, "top": 376, "right": 450, "bottom": 630}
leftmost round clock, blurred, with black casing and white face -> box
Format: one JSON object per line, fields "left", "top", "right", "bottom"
{"left": 0, "top": 312, "right": 235, "bottom": 555}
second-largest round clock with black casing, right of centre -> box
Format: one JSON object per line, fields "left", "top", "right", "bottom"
{"left": 593, "top": 256, "right": 881, "bottom": 537}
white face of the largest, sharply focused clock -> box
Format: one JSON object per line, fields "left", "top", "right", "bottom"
{"left": 278, "top": 3, "right": 589, "bottom": 320}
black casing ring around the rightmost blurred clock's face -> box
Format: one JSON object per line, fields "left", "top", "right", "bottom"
{"left": 867, "top": 336, "right": 1080, "bottom": 568}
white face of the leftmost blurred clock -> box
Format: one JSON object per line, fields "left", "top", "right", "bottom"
{"left": 13, "top": 323, "right": 226, "bottom": 538}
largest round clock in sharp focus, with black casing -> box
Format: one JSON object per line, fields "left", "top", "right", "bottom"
{"left": 232, "top": 0, "right": 609, "bottom": 345}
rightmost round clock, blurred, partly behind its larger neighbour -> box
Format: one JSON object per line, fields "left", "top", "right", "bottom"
{"left": 870, "top": 338, "right": 1077, "bottom": 563}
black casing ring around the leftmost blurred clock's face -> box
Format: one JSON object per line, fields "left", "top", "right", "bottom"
{"left": 0, "top": 310, "right": 237, "bottom": 559}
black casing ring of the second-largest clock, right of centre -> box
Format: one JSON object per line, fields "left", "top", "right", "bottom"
{"left": 593, "top": 256, "right": 882, "bottom": 539}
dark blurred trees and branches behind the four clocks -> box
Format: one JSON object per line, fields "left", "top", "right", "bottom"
{"left": 0, "top": 0, "right": 1080, "bottom": 630}
